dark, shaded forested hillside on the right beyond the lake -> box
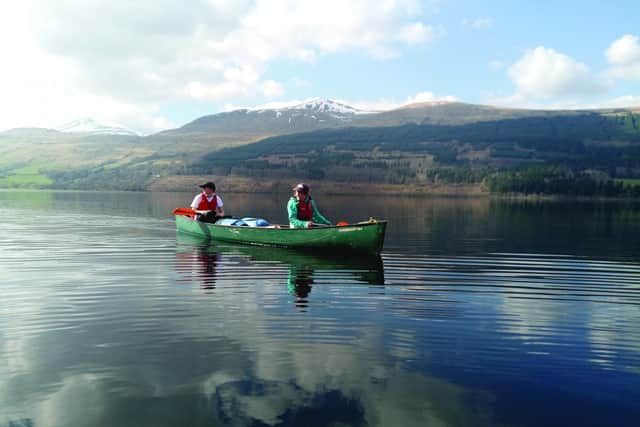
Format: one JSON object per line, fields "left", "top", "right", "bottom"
{"left": 190, "top": 112, "right": 640, "bottom": 197}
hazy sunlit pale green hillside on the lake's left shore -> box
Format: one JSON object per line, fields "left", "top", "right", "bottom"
{"left": 0, "top": 129, "right": 257, "bottom": 190}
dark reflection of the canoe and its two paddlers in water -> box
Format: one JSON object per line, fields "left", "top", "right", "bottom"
{"left": 176, "top": 233, "right": 384, "bottom": 298}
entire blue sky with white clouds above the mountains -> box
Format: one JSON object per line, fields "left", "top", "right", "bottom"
{"left": 0, "top": 0, "right": 640, "bottom": 133}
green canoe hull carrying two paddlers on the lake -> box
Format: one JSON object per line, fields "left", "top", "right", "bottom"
{"left": 175, "top": 215, "right": 387, "bottom": 253}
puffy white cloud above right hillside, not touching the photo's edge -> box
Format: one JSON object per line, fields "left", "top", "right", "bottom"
{"left": 508, "top": 46, "right": 605, "bottom": 100}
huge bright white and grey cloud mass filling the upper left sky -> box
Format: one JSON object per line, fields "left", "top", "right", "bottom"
{"left": 0, "top": 0, "right": 433, "bottom": 131}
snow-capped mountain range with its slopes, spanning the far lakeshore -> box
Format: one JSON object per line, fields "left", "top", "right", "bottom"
{"left": 0, "top": 98, "right": 640, "bottom": 193}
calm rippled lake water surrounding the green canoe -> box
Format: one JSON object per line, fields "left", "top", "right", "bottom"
{"left": 0, "top": 191, "right": 640, "bottom": 427}
